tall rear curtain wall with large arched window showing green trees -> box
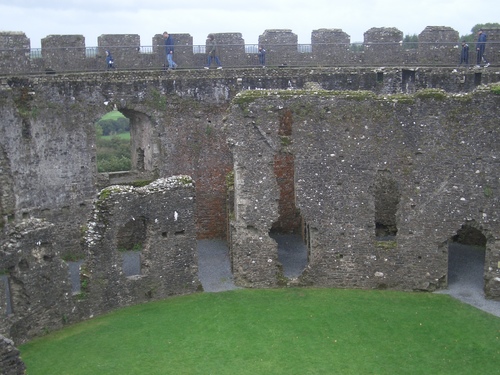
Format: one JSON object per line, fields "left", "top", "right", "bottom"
{"left": 0, "top": 69, "right": 500, "bottom": 254}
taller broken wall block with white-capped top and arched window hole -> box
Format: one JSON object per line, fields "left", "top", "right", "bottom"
{"left": 82, "top": 176, "right": 200, "bottom": 314}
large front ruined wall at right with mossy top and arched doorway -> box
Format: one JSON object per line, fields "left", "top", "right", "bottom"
{"left": 228, "top": 90, "right": 500, "bottom": 299}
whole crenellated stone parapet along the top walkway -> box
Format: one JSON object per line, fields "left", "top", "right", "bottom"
{"left": 0, "top": 26, "right": 500, "bottom": 74}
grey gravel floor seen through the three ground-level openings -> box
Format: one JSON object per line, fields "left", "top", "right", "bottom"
{"left": 198, "top": 239, "right": 500, "bottom": 317}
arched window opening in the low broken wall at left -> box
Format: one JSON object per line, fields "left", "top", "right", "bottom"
{"left": 116, "top": 217, "right": 147, "bottom": 277}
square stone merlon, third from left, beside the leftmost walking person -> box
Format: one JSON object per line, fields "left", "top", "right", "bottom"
{"left": 97, "top": 34, "right": 141, "bottom": 69}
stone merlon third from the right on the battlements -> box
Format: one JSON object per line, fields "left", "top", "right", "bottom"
{"left": 363, "top": 27, "right": 403, "bottom": 66}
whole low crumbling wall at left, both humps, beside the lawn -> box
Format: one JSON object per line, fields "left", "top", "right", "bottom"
{"left": 0, "top": 176, "right": 200, "bottom": 344}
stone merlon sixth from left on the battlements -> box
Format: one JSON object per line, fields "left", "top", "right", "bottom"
{"left": 259, "top": 29, "right": 299, "bottom": 66}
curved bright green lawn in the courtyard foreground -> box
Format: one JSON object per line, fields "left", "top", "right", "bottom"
{"left": 20, "top": 289, "right": 500, "bottom": 375}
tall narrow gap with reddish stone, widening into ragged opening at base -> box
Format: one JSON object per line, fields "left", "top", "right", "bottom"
{"left": 269, "top": 110, "right": 308, "bottom": 278}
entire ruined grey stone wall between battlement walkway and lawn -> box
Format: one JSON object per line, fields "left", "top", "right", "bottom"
{"left": 0, "top": 68, "right": 500, "bottom": 343}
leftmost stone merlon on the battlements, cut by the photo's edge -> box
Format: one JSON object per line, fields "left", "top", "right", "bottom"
{"left": 0, "top": 32, "right": 30, "bottom": 73}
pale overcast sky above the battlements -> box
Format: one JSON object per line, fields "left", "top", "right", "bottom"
{"left": 0, "top": 0, "right": 500, "bottom": 48}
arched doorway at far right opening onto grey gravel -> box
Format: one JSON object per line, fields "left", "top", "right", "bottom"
{"left": 448, "top": 224, "right": 486, "bottom": 297}
